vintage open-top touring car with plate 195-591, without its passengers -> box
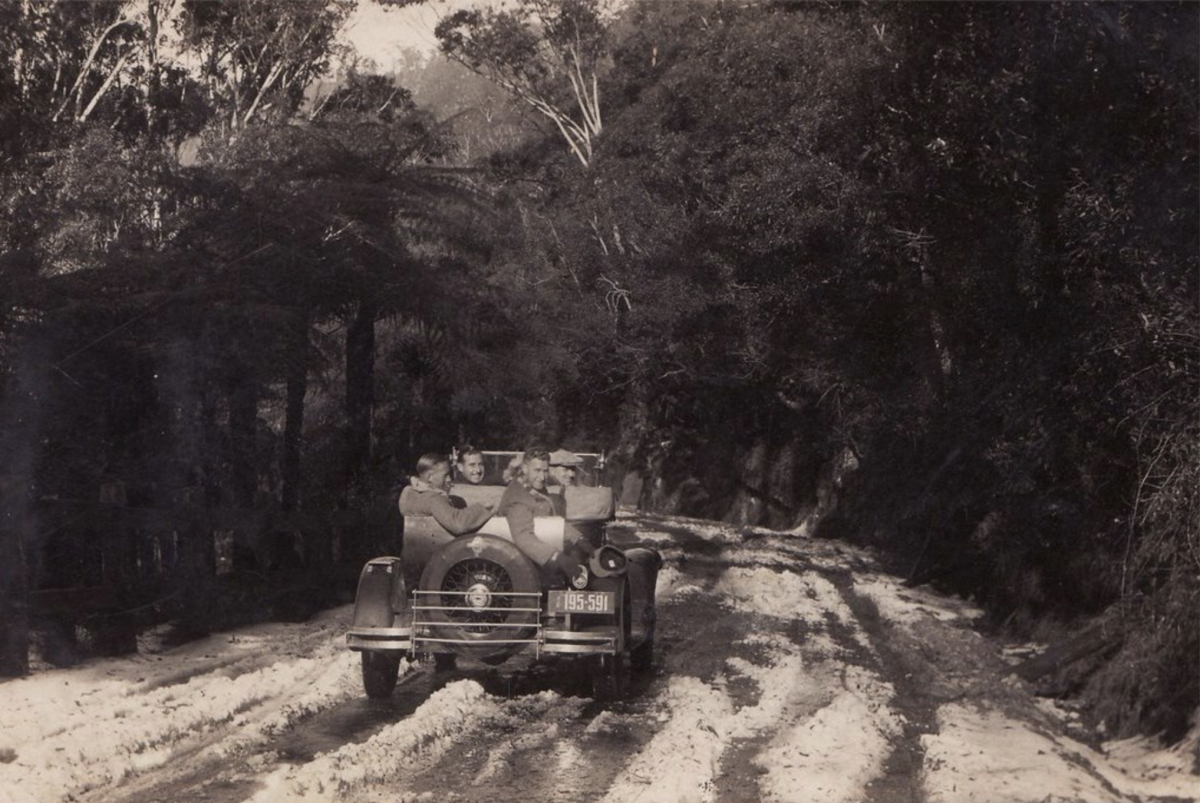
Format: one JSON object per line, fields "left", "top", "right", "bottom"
{"left": 347, "top": 451, "right": 662, "bottom": 700}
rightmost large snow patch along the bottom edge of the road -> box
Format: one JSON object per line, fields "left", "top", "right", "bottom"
{"left": 920, "top": 703, "right": 1123, "bottom": 803}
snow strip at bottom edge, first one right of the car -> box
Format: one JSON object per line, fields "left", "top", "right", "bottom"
{"left": 602, "top": 677, "right": 733, "bottom": 803}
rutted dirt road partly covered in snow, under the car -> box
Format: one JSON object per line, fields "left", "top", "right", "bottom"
{"left": 0, "top": 517, "right": 1200, "bottom": 803}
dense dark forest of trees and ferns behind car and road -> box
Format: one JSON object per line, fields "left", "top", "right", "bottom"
{"left": 0, "top": 0, "right": 1200, "bottom": 736}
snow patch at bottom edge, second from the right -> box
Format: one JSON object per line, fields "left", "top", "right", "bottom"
{"left": 755, "top": 666, "right": 904, "bottom": 803}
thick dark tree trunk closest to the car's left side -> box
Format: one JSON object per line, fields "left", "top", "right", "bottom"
{"left": 346, "top": 300, "right": 378, "bottom": 501}
